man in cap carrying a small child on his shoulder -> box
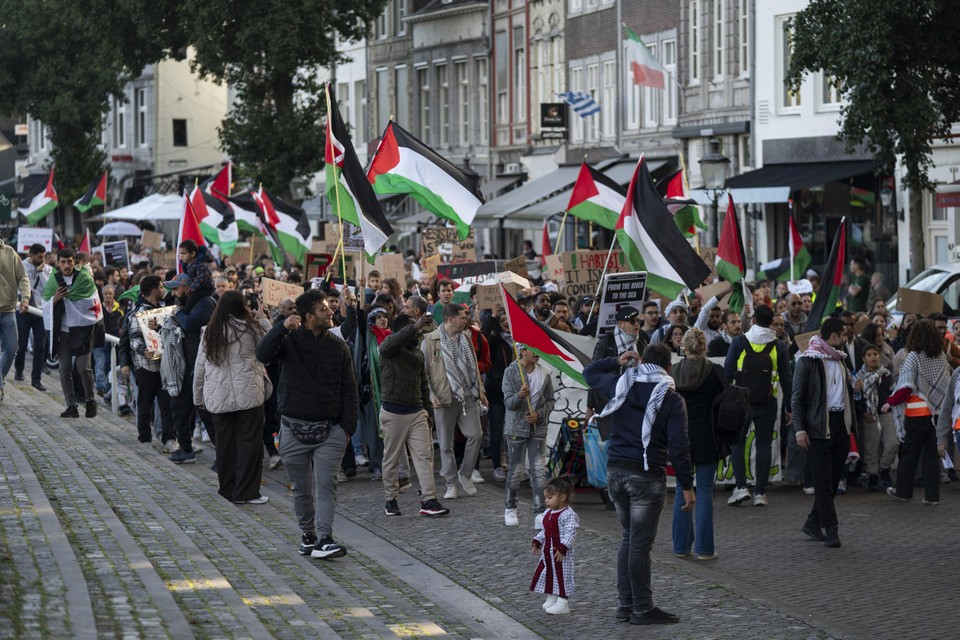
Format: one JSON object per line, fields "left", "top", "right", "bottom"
{"left": 160, "top": 273, "right": 217, "bottom": 464}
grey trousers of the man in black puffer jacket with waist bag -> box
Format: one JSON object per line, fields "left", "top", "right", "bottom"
{"left": 280, "top": 418, "right": 350, "bottom": 539}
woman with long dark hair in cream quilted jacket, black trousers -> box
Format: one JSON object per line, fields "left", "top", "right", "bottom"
{"left": 193, "top": 291, "right": 272, "bottom": 504}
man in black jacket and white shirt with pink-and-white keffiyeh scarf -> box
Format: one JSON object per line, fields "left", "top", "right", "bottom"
{"left": 791, "top": 318, "right": 855, "bottom": 547}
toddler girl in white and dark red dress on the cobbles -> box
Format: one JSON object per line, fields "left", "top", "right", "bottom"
{"left": 530, "top": 478, "right": 580, "bottom": 614}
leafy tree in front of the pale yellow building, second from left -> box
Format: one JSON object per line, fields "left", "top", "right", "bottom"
{"left": 182, "top": 0, "right": 387, "bottom": 192}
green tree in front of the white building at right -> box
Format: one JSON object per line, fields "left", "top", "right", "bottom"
{"left": 785, "top": 0, "right": 960, "bottom": 274}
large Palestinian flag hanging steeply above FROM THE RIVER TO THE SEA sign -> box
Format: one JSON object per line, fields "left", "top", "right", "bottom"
{"left": 616, "top": 157, "right": 710, "bottom": 299}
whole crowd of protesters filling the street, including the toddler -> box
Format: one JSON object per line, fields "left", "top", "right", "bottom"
{"left": 0, "top": 232, "right": 960, "bottom": 624}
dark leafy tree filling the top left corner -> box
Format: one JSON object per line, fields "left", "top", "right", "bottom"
{"left": 0, "top": 0, "right": 184, "bottom": 208}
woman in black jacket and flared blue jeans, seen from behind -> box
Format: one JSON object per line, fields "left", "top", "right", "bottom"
{"left": 673, "top": 328, "right": 727, "bottom": 560}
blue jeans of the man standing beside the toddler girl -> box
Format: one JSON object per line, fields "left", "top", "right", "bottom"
{"left": 607, "top": 467, "right": 667, "bottom": 613}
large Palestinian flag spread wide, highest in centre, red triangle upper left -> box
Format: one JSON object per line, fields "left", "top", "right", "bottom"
{"left": 367, "top": 122, "right": 484, "bottom": 240}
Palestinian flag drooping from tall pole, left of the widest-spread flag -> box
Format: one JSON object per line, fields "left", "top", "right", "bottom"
{"left": 324, "top": 82, "right": 393, "bottom": 259}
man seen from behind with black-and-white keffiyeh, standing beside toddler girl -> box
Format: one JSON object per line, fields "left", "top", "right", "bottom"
{"left": 583, "top": 344, "right": 696, "bottom": 624}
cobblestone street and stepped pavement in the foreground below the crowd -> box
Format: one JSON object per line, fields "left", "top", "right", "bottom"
{"left": 0, "top": 372, "right": 960, "bottom": 639}
